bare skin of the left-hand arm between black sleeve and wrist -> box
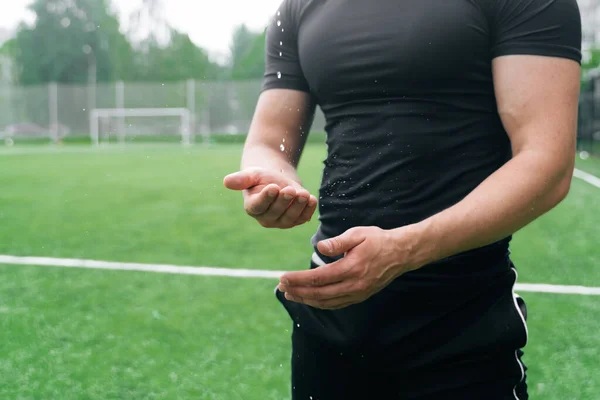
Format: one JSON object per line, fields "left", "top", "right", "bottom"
{"left": 246, "top": 89, "right": 315, "bottom": 165}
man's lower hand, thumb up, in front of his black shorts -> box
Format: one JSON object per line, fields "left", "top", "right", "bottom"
{"left": 278, "top": 227, "right": 418, "bottom": 310}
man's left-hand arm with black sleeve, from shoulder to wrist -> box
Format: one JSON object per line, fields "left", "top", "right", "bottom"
{"left": 246, "top": 0, "right": 315, "bottom": 165}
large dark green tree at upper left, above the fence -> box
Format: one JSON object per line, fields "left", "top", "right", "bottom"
{"left": 16, "top": 0, "right": 132, "bottom": 84}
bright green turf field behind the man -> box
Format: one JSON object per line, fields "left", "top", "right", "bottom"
{"left": 0, "top": 144, "right": 600, "bottom": 400}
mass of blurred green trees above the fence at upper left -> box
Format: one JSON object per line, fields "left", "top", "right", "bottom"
{"left": 11, "top": 0, "right": 223, "bottom": 85}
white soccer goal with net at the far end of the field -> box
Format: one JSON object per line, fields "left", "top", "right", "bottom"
{"left": 90, "top": 108, "right": 194, "bottom": 145}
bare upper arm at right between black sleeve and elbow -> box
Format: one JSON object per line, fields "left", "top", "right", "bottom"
{"left": 493, "top": 55, "right": 580, "bottom": 157}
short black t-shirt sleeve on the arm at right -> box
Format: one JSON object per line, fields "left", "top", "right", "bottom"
{"left": 488, "top": 0, "right": 581, "bottom": 63}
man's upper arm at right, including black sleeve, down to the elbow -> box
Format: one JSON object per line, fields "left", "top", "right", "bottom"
{"left": 490, "top": 0, "right": 581, "bottom": 159}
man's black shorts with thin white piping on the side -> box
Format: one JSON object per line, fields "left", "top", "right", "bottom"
{"left": 276, "top": 252, "right": 528, "bottom": 400}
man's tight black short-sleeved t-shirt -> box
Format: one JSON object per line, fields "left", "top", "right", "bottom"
{"left": 263, "top": 0, "right": 581, "bottom": 348}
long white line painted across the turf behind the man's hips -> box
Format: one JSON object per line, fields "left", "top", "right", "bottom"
{"left": 0, "top": 255, "right": 600, "bottom": 296}
